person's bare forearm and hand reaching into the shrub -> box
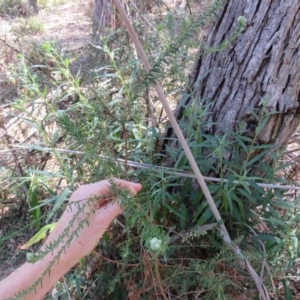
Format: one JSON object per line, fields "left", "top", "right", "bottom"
{"left": 0, "top": 179, "right": 142, "bottom": 300}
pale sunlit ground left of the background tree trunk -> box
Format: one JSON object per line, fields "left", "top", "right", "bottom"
{"left": 0, "top": 0, "right": 92, "bottom": 104}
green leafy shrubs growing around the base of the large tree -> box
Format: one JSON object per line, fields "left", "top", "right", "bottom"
{"left": 0, "top": 1, "right": 299, "bottom": 299}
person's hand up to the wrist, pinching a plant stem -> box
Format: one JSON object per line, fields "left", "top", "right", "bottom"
{"left": 45, "top": 178, "right": 142, "bottom": 262}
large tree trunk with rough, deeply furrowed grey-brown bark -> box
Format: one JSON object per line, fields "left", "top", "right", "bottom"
{"left": 167, "top": 0, "right": 300, "bottom": 154}
